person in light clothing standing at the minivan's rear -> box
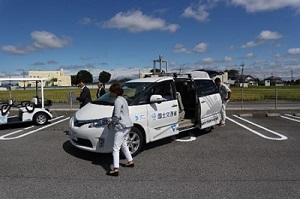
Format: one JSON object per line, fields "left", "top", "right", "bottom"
{"left": 215, "top": 77, "right": 231, "bottom": 126}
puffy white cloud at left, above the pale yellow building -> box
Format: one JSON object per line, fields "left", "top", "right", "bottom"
{"left": 31, "top": 31, "right": 72, "bottom": 48}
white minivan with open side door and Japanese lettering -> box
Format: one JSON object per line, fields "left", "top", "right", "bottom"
{"left": 69, "top": 71, "right": 222, "bottom": 156}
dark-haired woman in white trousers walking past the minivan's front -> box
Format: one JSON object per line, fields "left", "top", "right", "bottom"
{"left": 106, "top": 83, "right": 134, "bottom": 176}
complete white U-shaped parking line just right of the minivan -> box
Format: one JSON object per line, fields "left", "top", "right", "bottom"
{"left": 227, "top": 115, "right": 288, "bottom": 141}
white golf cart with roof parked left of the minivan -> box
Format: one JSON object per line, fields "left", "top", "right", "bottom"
{"left": 0, "top": 78, "right": 52, "bottom": 125}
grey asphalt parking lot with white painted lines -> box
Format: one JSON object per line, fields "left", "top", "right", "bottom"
{"left": 0, "top": 112, "right": 300, "bottom": 198}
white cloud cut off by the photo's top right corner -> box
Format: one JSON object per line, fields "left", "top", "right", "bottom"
{"left": 231, "top": 0, "right": 300, "bottom": 12}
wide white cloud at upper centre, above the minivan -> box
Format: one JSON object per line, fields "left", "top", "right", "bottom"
{"left": 104, "top": 10, "right": 180, "bottom": 32}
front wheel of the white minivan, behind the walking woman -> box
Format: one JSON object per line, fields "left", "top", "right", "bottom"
{"left": 128, "top": 126, "right": 144, "bottom": 157}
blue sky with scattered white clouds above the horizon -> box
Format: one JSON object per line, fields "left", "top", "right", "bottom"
{"left": 0, "top": 0, "right": 300, "bottom": 80}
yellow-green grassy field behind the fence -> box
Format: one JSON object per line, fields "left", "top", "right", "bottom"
{"left": 0, "top": 86, "right": 300, "bottom": 103}
